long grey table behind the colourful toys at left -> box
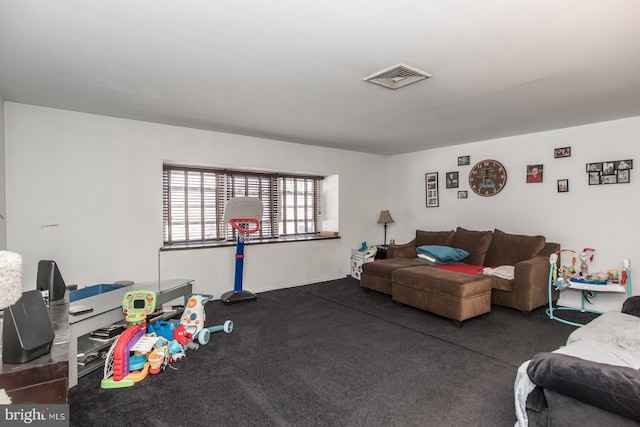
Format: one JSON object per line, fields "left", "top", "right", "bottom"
{"left": 69, "top": 279, "right": 193, "bottom": 388}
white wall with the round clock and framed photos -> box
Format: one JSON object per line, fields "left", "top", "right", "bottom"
{"left": 388, "top": 117, "right": 640, "bottom": 310}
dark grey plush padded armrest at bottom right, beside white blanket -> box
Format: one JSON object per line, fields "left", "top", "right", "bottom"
{"left": 527, "top": 353, "right": 640, "bottom": 421}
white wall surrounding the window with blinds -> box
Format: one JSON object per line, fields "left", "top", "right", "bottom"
{"left": 5, "top": 103, "right": 387, "bottom": 298}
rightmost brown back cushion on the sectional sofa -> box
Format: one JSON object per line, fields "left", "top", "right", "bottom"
{"left": 484, "top": 228, "right": 546, "bottom": 266}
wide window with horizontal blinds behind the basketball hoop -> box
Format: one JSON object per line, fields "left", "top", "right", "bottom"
{"left": 162, "top": 165, "right": 323, "bottom": 245}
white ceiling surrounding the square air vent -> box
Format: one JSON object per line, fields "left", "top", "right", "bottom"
{"left": 0, "top": 0, "right": 640, "bottom": 154}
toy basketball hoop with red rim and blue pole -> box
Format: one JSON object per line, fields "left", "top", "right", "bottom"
{"left": 221, "top": 197, "right": 263, "bottom": 304}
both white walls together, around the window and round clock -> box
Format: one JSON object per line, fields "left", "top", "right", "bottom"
{"left": 4, "top": 103, "right": 640, "bottom": 309}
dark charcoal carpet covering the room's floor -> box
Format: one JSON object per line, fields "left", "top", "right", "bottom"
{"left": 69, "top": 278, "right": 592, "bottom": 427}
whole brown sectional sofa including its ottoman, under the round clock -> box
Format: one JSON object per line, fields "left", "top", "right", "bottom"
{"left": 360, "top": 227, "right": 560, "bottom": 326}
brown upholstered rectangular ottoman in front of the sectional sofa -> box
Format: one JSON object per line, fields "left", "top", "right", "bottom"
{"left": 391, "top": 266, "right": 491, "bottom": 327}
